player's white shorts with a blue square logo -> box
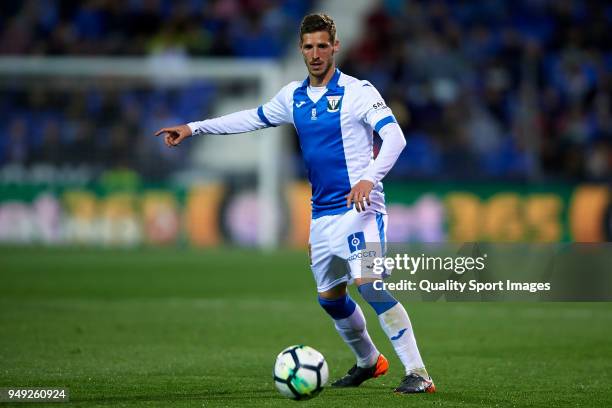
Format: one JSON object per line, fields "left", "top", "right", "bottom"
{"left": 309, "top": 208, "right": 387, "bottom": 292}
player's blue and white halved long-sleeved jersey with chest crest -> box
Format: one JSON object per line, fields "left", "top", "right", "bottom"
{"left": 189, "top": 70, "right": 405, "bottom": 218}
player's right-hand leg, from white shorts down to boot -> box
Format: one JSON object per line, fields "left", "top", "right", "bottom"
{"left": 338, "top": 211, "right": 435, "bottom": 393}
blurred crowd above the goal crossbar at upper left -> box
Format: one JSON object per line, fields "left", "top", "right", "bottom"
{"left": 0, "top": 0, "right": 311, "bottom": 58}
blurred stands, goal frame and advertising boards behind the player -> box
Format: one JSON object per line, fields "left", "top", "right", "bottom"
{"left": 0, "top": 0, "right": 612, "bottom": 248}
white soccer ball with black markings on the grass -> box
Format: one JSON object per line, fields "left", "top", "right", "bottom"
{"left": 274, "top": 346, "right": 329, "bottom": 400}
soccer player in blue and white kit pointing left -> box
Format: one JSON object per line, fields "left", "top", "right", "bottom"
{"left": 156, "top": 14, "right": 435, "bottom": 393}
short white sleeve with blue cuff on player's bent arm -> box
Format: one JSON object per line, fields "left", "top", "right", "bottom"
{"left": 355, "top": 81, "right": 397, "bottom": 133}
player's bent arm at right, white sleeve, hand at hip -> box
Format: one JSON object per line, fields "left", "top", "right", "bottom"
{"left": 346, "top": 82, "right": 406, "bottom": 212}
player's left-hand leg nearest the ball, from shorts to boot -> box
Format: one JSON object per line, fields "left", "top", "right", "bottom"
{"left": 310, "top": 217, "right": 386, "bottom": 386}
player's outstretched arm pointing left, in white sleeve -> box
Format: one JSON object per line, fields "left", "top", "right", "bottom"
{"left": 155, "top": 84, "right": 293, "bottom": 147}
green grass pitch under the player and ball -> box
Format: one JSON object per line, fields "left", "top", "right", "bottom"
{"left": 0, "top": 248, "right": 612, "bottom": 407}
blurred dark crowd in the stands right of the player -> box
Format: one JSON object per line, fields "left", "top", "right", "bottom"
{"left": 343, "top": 0, "right": 612, "bottom": 179}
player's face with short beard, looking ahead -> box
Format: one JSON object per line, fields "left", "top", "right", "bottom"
{"left": 300, "top": 31, "right": 340, "bottom": 78}
